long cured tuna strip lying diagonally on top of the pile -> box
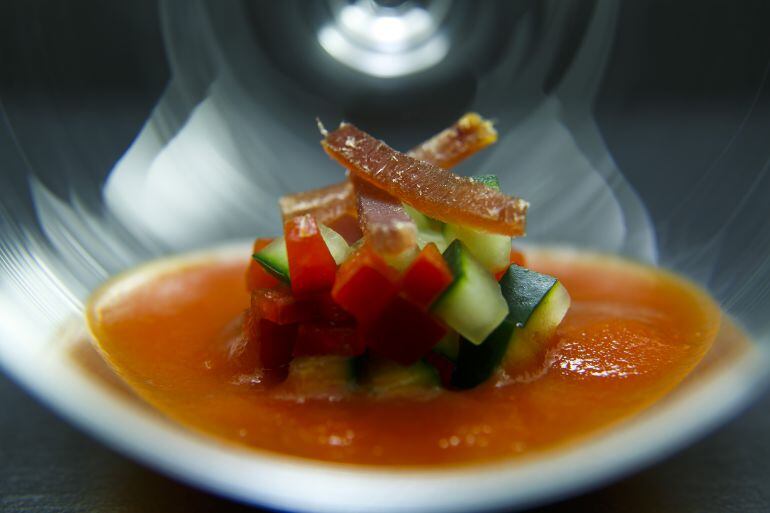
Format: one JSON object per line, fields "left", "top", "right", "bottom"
{"left": 321, "top": 123, "right": 529, "bottom": 236}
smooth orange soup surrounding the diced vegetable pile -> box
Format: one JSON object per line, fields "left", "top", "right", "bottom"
{"left": 88, "top": 246, "right": 721, "bottom": 465}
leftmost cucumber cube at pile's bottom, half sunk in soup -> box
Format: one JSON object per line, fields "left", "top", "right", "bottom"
{"left": 283, "top": 355, "right": 356, "bottom": 399}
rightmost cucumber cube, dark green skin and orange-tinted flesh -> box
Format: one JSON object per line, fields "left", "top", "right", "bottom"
{"left": 500, "top": 264, "right": 571, "bottom": 364}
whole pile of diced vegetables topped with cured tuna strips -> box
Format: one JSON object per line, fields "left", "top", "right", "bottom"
{"left": 244, "top": 114, "right": 570, "bottom": 396}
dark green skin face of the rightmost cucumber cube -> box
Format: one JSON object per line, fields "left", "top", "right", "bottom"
{"left": 500, "top": 264, "right": 558, "bottom": 327}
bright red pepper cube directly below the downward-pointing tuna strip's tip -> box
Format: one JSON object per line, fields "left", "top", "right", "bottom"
{"left": 332, "top": 246, "right": 398, "bottom": 322}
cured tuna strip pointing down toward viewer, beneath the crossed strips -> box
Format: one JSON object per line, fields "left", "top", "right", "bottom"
{"left": 350, "top": 176, "right": 417, "bottom": 255}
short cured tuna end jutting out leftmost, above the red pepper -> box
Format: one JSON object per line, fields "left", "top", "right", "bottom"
{"left": 278, "top": 180, "right": 356, "bottom": 224}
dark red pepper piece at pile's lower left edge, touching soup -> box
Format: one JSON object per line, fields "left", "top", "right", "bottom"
{"left": 243, "top": 311, "right": 297, "bottom": 378}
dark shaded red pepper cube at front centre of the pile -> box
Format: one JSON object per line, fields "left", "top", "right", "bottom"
{"left": 365, "top": 296, "right": 446, "bottom": 365}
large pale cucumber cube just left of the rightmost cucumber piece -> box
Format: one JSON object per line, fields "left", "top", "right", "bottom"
{"left": 431, "top": 240, "right": 508, "bottom": 344}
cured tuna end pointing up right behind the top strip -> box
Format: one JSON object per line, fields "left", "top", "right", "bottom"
{"left": 407, "top": 112, "right": 497, "bottom": 169}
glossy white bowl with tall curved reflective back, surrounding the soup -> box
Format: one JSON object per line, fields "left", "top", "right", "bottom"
{"left": 0, "top": 0, "right": 770, "bottom": 512}
